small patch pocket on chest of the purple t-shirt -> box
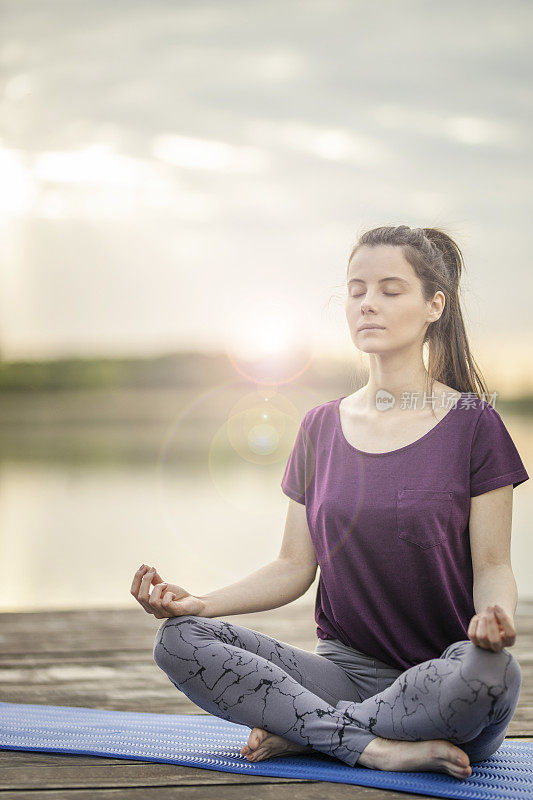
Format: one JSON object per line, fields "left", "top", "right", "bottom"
{"left": 396, "top": 489, "right": 453, "bottom": 550}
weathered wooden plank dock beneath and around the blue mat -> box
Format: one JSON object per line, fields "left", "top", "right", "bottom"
{"left": 0, "top": 604, "right": 533, "bottom": 800}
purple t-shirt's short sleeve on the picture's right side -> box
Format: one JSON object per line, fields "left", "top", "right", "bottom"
{"left": 470, "top": 403, "right": 529, "bottom": 497}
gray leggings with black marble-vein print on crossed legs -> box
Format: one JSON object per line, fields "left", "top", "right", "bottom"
{"left": 153, "top": 615, "right": 522, "bottom": 766}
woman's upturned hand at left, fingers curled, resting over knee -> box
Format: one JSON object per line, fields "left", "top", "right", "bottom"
{"left": 130, "top": 564, "right": 205, "bottom": 619}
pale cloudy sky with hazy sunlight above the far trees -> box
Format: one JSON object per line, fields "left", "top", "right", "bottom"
{"left": 0, "top": 0, "right": 533, "bottom": 389}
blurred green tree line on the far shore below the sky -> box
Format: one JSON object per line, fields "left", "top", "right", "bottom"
{"left": 0, "top": 351, "right": 533, "bottom": 412}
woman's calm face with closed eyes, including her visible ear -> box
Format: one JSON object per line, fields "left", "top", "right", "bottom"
{"left": 346, "top": 245, "right": 444, "bottom": 353}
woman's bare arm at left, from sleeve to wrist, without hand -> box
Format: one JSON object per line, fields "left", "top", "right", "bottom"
{"left": 199, "top": 498, "right": 318, "bottom": 617}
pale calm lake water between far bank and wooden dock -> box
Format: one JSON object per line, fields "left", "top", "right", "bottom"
{"left": 0, "top": 415, "right": 533, "bottom": 613}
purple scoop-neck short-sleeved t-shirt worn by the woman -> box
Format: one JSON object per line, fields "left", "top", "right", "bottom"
{"left": 281, "top": 392, "right": 529, "bottom": 671}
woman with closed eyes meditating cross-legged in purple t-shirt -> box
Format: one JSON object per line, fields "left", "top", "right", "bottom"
{"left": 131, "top": 225, "right": 529, "bottom": 779}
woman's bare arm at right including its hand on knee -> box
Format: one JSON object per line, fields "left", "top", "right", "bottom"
{"left": 468, "top": 484, "right": 518, "bottom": 651}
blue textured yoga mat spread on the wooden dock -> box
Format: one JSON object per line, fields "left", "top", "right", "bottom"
{"left": 0, "top": 702, "right": 533, "bottom": 800}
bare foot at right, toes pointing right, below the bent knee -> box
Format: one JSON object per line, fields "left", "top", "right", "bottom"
{"left": 357, "top": 736, "right": 472, "bottom": 779}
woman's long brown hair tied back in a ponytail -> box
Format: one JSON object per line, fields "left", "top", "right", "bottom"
{"left": 347, "top": 225, "right": 489, "bottom": 399}
